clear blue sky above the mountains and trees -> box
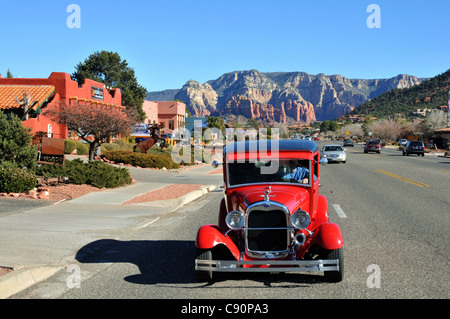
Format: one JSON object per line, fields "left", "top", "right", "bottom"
{"left": 0, "top": 0, "right": 450, "bottom": 91}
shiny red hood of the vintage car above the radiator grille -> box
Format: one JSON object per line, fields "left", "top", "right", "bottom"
{"left": 228, "top": 184, "right": 310, "bottom": 214}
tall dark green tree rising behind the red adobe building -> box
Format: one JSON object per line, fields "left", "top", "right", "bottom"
{"left": 71, "top": 51, "right": 147, "bottom": 121}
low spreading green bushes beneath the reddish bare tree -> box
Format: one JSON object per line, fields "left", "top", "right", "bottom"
{"left": 36, "top": 159, "right": 132, "bottom": 188}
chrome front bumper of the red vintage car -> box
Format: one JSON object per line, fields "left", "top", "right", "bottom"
{"left": 195, "top": 259, "right": 339, "bottom": 272}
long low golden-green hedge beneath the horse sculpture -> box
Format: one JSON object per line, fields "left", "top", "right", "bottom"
{"left": 103, "top": 151, "right": 180, "bottom": 169}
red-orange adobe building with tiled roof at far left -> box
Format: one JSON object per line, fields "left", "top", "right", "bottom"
{"left": 0, "top": 72, "right": 122, "bottom": 138}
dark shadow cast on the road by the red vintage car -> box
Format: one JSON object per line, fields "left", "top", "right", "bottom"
{"left": 75, "top": 239, "right": 324, "bottom": 288}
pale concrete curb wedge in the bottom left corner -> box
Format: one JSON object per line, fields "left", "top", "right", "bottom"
{"left": 0, "top": 266, "right": 63, "bottom": 299}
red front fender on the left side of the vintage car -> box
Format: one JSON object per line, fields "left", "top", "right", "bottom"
{"left": 195, "top": 225, "right": 240, "bottom": 260}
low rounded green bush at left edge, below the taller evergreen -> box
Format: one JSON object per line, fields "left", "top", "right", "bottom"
{"left": 0, "top": 166, "right": 36, "bottom": 193}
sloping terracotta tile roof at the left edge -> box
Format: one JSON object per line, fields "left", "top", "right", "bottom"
{"left": 0, "top": 85, "right": 55, "bottom": 110}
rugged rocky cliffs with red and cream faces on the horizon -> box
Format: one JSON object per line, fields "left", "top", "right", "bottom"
{"left": 150, "top": 70, "right": 421, "bottom": 124}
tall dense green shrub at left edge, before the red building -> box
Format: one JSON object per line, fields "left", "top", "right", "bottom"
{"left": 0, "top": 110, "right": 37, "bottom": 170}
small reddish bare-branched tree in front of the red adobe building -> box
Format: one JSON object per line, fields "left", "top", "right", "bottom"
{"left": 43, "top": 103, "right": 131, "bottom": 161}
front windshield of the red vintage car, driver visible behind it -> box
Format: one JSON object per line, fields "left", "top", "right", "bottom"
{"left": 227, "top": 160, "right": 310, "bottom": 186}
